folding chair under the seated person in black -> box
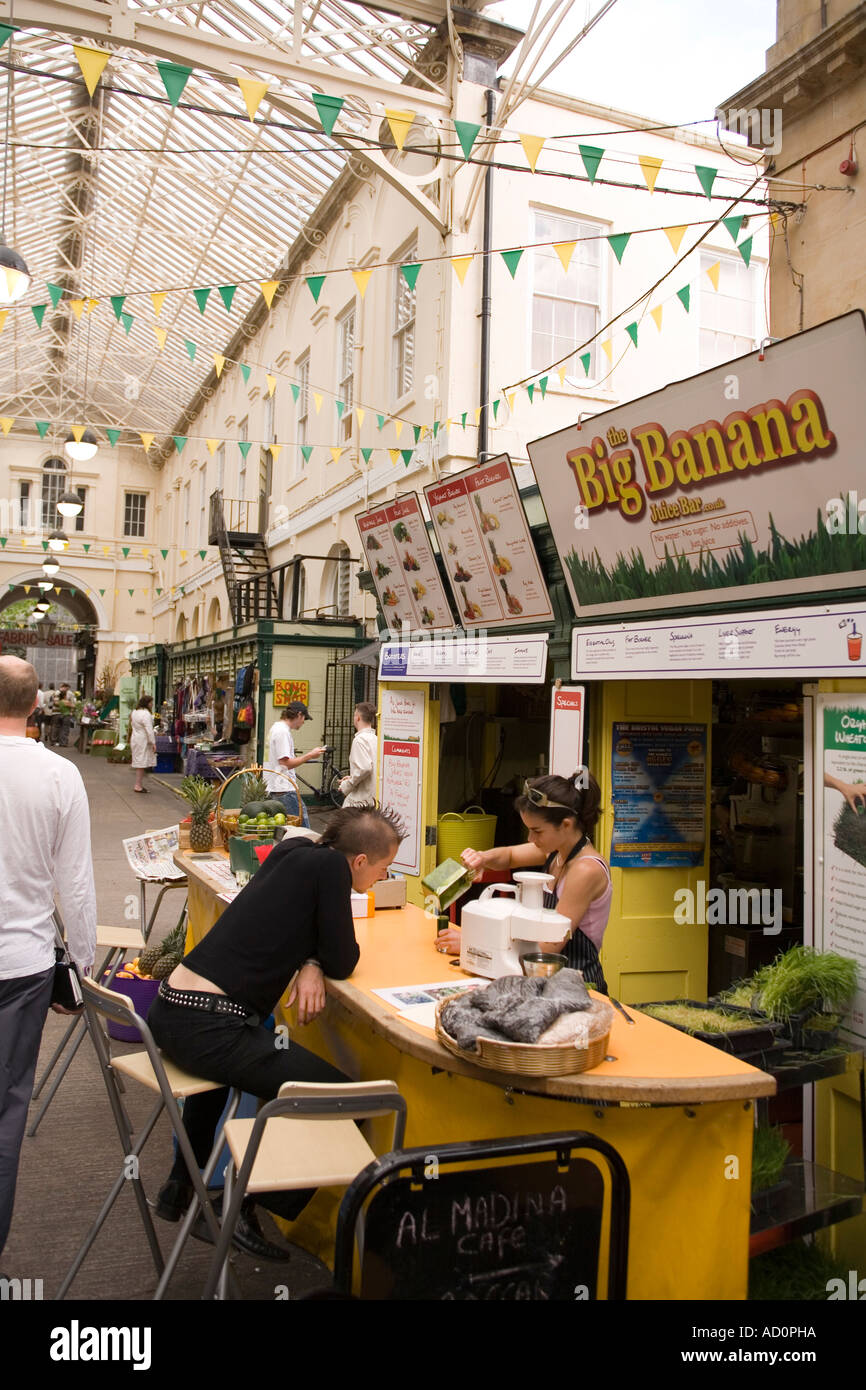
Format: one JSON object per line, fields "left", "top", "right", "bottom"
{"left": 57, "top": 980, "right": 240, "bottom": 1300}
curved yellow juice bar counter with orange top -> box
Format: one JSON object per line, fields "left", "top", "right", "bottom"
{"left": 178, "top": 855, "right": 776, "bottom": 1300}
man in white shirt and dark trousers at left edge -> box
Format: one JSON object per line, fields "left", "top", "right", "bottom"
{"left": 0, "top": 656, "right": 96, "bottom": 1251}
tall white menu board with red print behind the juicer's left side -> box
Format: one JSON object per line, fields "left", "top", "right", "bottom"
{"left": 378, "top": 689, "right": 427, "bottom": 874}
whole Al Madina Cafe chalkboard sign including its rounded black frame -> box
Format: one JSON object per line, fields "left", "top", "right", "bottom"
{"left": 334, "top": 1130, "right": 630, "bottom": 1302}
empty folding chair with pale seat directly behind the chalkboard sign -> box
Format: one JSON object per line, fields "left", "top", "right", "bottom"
{"left": 202, "top": 1081, "right": 406, "bottom": 1298}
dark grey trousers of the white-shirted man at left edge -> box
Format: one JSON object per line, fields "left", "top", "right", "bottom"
{"left": 0, "top": 969, "right": 54, "bottom": 1254}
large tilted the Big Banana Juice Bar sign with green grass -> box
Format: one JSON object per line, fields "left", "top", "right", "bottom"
{"left": 528, "top": 311, "right": 866, "bottom": 617}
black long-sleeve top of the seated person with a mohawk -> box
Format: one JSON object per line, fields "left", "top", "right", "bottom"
{"left": 183, "top": 838, "right": 360, "bottom": 1017}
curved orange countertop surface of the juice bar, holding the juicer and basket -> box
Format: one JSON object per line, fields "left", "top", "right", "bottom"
{"left": 175, "top": 851, "right": 776, "bottom": 1105}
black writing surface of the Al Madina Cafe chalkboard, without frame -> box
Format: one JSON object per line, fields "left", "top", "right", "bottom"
{"left": 361, "top": 1158, "right": 605, "bottom": 1302}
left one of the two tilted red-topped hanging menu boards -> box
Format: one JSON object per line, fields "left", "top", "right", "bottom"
{"left": 356, "top": 492, "right": 455, "bottom": 632}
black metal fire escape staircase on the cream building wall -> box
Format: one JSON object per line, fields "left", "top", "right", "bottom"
{"left": 207, "top": 491, "right": 279, "bottom": 626}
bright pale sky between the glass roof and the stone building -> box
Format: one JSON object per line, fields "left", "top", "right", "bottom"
{"left": 485, "top": 0, "right": 776, "bottom": 122}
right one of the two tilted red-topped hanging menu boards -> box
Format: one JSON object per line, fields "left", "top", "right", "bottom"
{"left": 424, "top": 453, "right": 553, "bottom": 627}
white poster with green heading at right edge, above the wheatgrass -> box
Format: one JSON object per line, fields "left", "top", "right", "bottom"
{"left": 815, "top": 694, "right": 866, "bottom": 1041}
